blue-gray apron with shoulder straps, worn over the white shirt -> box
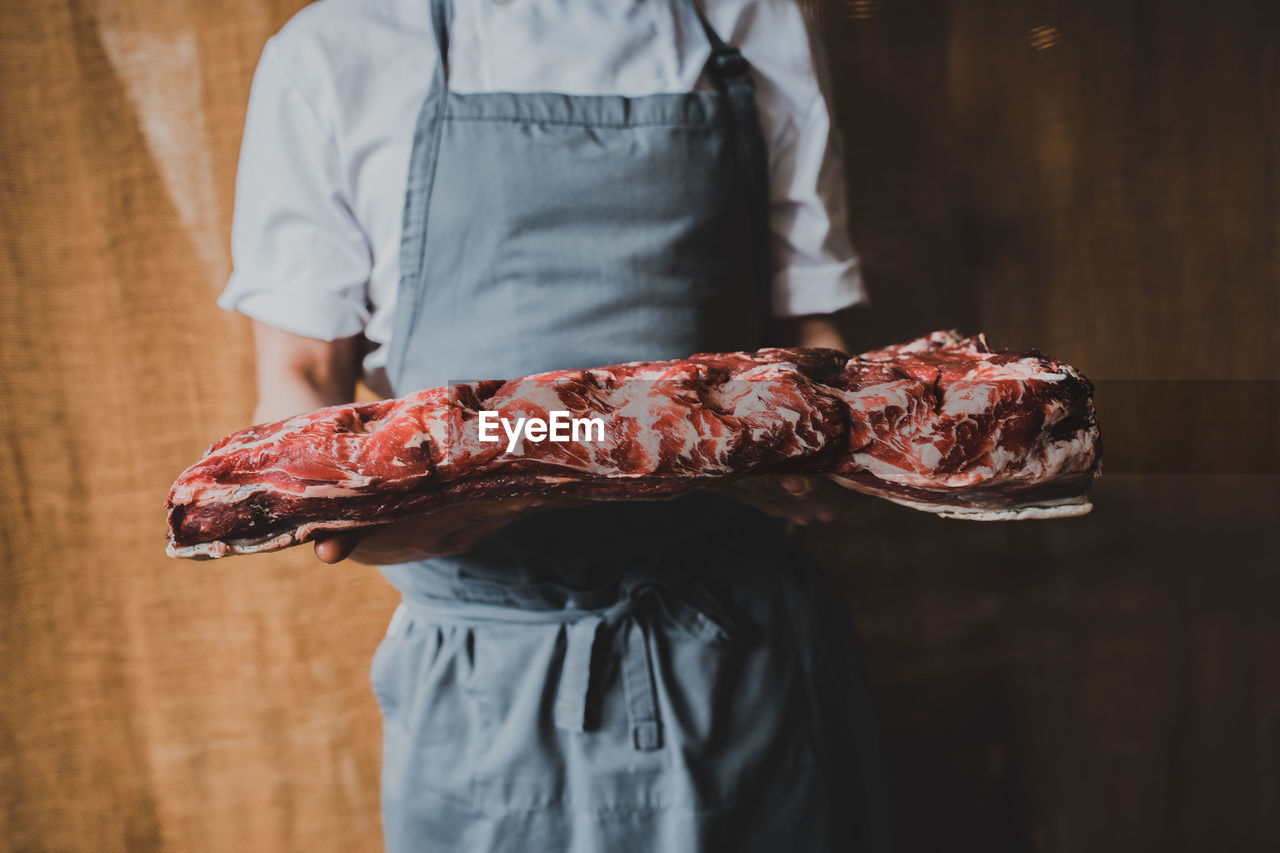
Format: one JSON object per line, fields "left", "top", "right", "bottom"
{"left": 372, "top": 0, "right": 883, "bottom": 853}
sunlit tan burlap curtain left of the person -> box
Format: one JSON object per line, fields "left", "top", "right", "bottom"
{"left": 0, "top": 0, "right": 394, "bottom": 850}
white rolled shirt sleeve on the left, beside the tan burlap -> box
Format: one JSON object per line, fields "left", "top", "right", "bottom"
{"left": 218, "top": 40, "right": 372, "bottom": 341}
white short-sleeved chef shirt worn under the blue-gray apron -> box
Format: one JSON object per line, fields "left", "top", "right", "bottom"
{"left": 219, "top": 0, "right": 865, "bottom": 386}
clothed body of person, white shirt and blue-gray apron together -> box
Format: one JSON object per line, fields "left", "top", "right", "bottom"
{"left": 224, "top": 0, "right": 884, "bottom": 853}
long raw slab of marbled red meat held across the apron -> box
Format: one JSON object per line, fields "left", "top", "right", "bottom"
{"left": 166, "top": 326, "right": 1101, "bottom": 557}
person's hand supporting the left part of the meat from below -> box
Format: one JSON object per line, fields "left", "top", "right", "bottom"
{"left": 315, "top": 497, "right": 561, "bottom": 566}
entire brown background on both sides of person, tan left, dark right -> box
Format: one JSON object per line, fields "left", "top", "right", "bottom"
{"left": 0, "top": 0, "right": 1280, "bottom": 853}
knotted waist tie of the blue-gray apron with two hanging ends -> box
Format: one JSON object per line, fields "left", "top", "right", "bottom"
{"left": 394, "top": 581, "right": 732, "bottom": 751}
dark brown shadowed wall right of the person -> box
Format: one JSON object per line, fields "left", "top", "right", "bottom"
{"left": 808, "top": 0, "right": 1280, "bottom": 853}
